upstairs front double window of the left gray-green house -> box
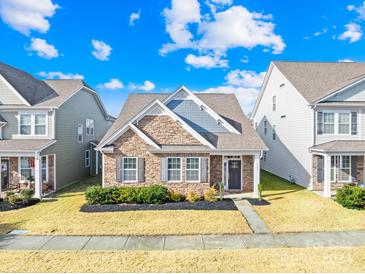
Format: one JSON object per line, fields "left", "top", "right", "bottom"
{"left": 19, "top": 113, "right": 47, "bottom": 136}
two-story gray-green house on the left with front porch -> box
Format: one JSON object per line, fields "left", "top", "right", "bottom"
{"left": 0, "top": 63, "right": 113, "bottom": 197}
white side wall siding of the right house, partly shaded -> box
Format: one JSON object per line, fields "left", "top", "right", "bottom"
{"left": 253, "top": 66, "right": 313, "bottom": 187}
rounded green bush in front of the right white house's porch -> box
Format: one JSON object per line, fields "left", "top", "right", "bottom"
{"left": 336, "top": 185, "right": 365, "bottom": 209}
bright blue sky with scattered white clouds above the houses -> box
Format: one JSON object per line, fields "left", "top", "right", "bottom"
{"left": 0, "top": 0, "right": 365, "bottom": 115}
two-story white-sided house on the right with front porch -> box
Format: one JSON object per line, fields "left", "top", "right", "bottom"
{"left": 252, "top": 62, "right": 365, "bottom": 197}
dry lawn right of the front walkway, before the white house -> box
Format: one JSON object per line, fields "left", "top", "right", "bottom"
{"left": 255, "top": 172, "right": 365, "bottom": 232}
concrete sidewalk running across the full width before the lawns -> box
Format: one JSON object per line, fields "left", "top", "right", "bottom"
{"left": 0, "top": 231, "right": 365, "bottom": 250}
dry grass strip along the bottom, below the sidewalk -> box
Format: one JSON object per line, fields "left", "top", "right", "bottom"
{"left": 0, "top": 248, "right": 365, "bottom": 272}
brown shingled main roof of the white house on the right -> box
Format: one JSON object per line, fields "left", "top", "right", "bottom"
{"left": 273, "top": 61, "right": 365, "bottom": 104}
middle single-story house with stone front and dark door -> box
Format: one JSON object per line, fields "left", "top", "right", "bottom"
{"left": 97, "top": 87, "right": 266, "bottom": 196}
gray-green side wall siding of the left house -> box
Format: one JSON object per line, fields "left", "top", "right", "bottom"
{"left": 42, "top": 90, "right": 110, "bottom": 189}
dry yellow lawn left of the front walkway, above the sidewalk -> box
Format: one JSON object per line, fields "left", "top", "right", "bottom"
{"left": 0, "top": 178, "right": 251, "bottom": 235}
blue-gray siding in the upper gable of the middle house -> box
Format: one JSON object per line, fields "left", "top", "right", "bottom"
{"left": 167, "top": 100, "right": 228, "bottom": 132}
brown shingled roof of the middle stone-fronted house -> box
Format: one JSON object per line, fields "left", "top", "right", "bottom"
{"left": 100, "top": 90, "right": 267, "bottom": 150}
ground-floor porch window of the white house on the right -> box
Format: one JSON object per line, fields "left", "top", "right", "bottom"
{"left": 331, "top": 155, "right": 352, "bottom": 182}
